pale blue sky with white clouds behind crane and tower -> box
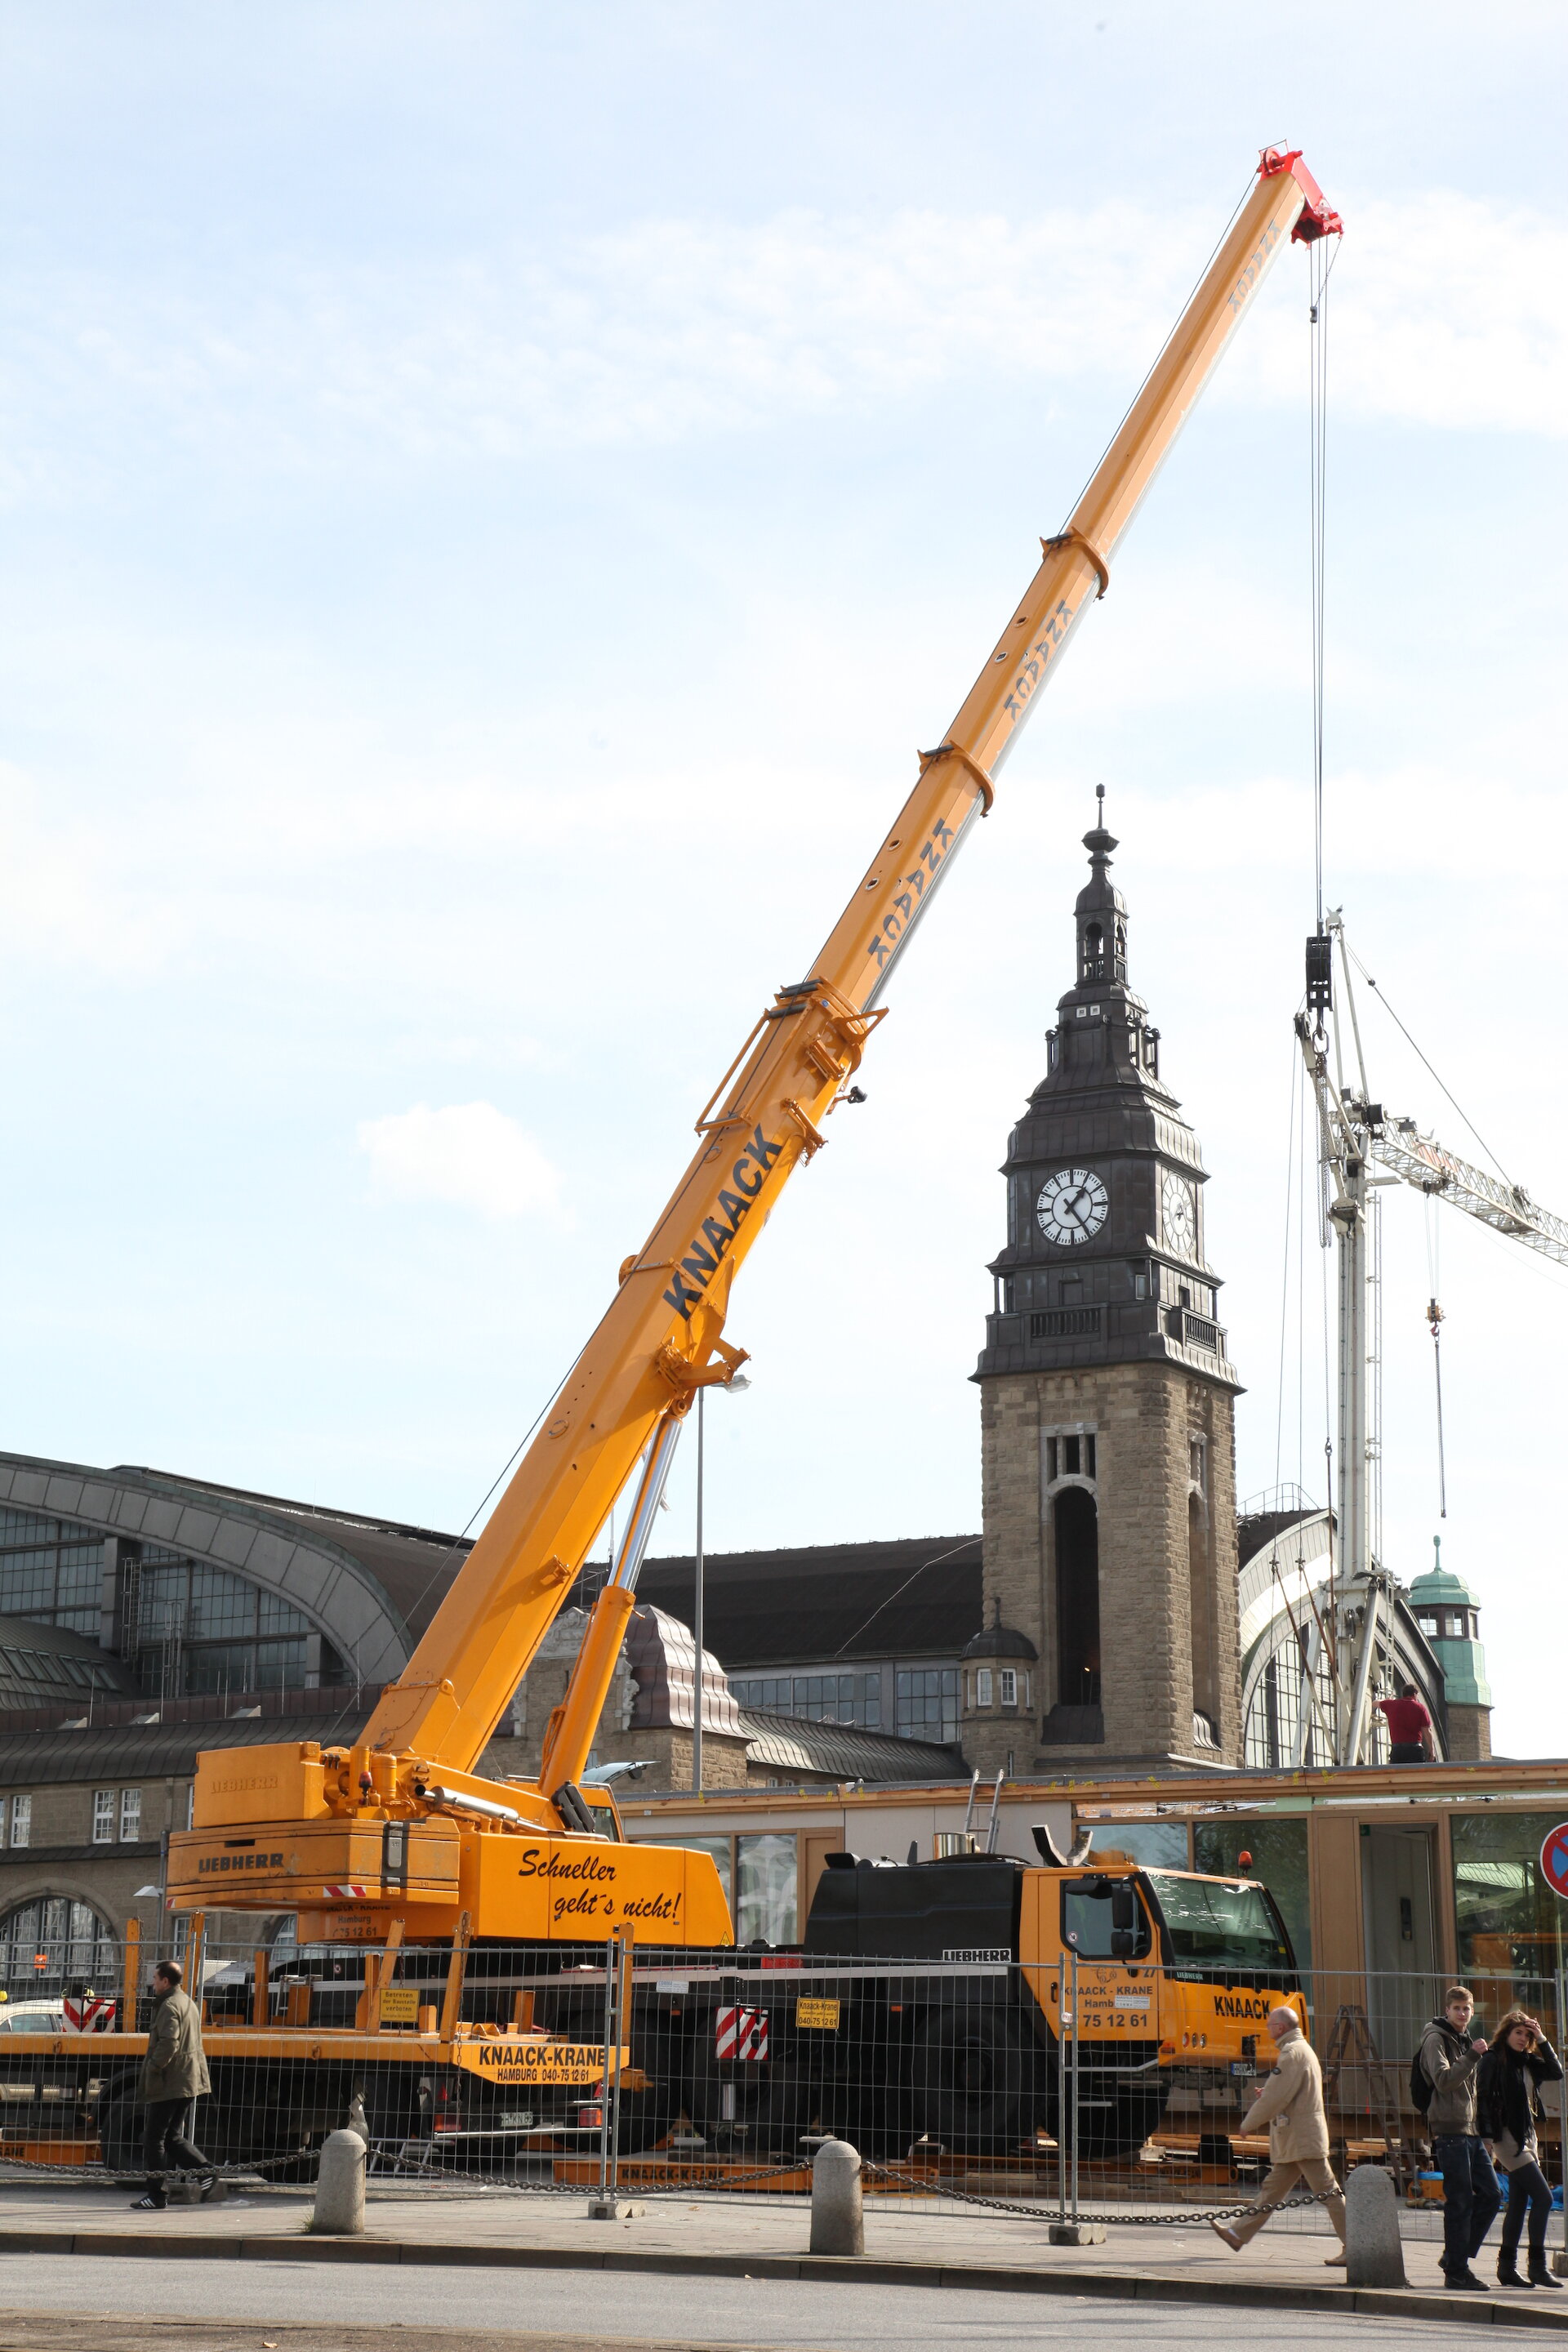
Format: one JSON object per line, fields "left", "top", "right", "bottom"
{"left": 0, "top": 0, "right": 1568, "bottom": 1754}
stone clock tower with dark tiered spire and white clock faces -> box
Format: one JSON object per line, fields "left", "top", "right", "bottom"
{"left": 964, "top": 795, "right": 1241, "bottom": 1774}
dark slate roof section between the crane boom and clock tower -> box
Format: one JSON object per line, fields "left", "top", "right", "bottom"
{"left": 637, "top": 1536, "right": 982, "bottom": 1674}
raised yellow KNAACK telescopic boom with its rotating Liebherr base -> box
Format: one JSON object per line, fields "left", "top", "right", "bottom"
{"left": 169, "top": 148, "right": 1340, "bottom": 1940}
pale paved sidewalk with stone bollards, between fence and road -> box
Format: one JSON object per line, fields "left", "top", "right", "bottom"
{"left": 0, "top": 2183, "right": 1568, "bottom": 2333}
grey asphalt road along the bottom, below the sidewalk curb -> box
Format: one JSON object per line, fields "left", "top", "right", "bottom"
{"left": 0, "top": 2253, "right": 1467, "bottom": 2352}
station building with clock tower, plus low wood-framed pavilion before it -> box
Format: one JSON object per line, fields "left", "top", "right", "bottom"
{"left": 0, "top": 823, "right": 1532, "bottom": 1994}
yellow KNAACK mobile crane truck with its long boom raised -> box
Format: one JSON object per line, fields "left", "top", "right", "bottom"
{"left": 14, "top": 148, "right": 1340, "bottom": 2162}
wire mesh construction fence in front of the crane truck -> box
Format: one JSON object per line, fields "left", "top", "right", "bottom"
{"left": 0, "top": 1933, "right": 1563, "bottom": 2234}
